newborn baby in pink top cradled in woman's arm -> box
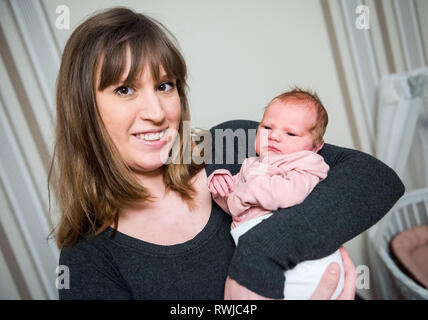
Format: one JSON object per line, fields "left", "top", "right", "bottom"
{"left": 208, "top": 89, "right": 344, "bottom": 300}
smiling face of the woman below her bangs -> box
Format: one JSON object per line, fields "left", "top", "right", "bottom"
{"left": 96, "top": 52, "right": 181, "bottom": 175}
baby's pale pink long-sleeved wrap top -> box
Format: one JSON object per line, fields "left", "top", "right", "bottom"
{"left": 208, "top": 150, "right": 329, "bottom": 229}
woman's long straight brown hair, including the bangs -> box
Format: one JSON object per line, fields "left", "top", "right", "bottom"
{"left": 48, "top": 7, "right": 202, "bottom": 248}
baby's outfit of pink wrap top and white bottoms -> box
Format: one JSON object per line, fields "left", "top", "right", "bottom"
{"left": 208, "top": 151, "right": 345, "bottom": 300}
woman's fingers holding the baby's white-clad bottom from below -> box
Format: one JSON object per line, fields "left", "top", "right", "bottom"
{"left": 311, "top": 247, "right": 357, "bottom": 300}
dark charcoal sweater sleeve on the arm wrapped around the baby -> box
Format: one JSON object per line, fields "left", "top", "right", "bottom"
{"left": 207, "top": 120, "right": 404, "bottom": 298}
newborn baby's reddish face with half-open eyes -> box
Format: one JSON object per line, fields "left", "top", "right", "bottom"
{"left": 256, "top": 99, "right": 319, "bottom": 155}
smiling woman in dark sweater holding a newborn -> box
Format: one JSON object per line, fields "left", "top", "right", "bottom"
{"left": 50, "top": 8, "right": 403, "bottom": 299}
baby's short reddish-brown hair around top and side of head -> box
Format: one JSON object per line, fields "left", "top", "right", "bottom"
{"left": 266, "top": 87, "right": 328, "bottom": 145}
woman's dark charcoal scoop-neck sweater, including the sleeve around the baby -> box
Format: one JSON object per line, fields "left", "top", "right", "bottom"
{"left": 59, "top": 120, "right": 404, "bottom": 299}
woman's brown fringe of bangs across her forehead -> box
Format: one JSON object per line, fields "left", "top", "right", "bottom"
{"left": 98, "top": 26, "right": 186, "bottom": 91}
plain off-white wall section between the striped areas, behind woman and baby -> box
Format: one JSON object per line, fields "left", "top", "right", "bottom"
{"left": 43, "top": 0, "right": 354, "bottom": 147}
